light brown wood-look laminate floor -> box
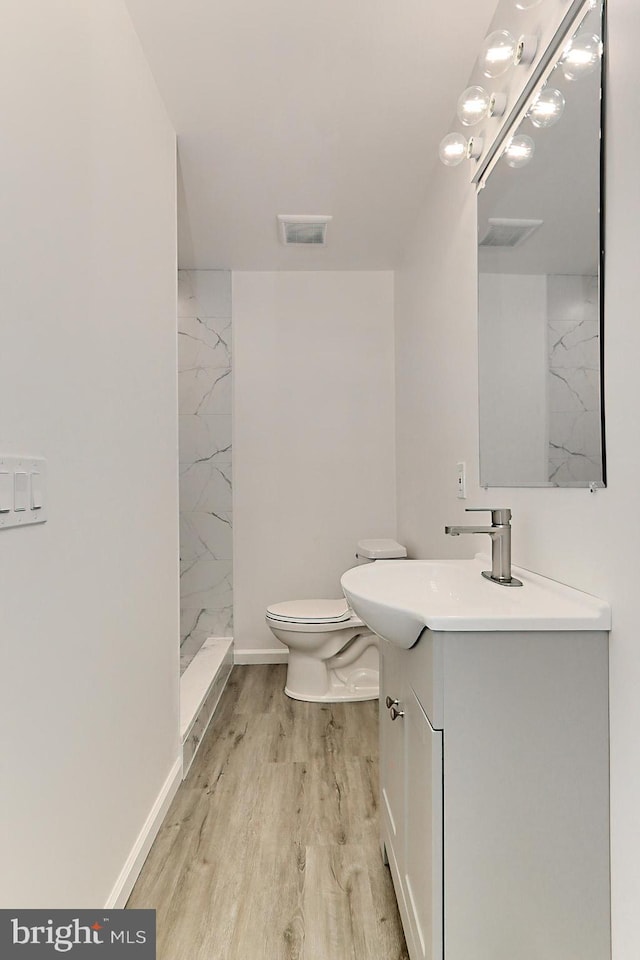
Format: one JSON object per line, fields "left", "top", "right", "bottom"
{"left": 128, "top": 664, "right": 407, "bottom": 960}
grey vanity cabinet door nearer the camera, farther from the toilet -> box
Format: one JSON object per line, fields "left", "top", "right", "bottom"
{"left": 403, "top": 689, "right": 444, "bottom": 960}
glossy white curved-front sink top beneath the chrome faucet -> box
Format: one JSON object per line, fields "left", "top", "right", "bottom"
{"left": 341, "top": 557, "right": 611, "bottom": 649}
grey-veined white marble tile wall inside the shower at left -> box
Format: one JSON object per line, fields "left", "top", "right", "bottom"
{"left": 178, "top": 270, "right": 233, "bottom": 670}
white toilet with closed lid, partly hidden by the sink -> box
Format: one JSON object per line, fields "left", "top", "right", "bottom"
{"left": 266, "top": 540, "right": 407, "bottom": 703}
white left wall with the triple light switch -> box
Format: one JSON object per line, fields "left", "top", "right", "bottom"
{"left": 0, "top": 0, "right": 180, "bottom": 907}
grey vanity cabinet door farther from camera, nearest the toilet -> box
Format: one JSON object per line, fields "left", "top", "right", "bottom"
{"left": 380, "top": 640, "right": 405, "bottom": 879}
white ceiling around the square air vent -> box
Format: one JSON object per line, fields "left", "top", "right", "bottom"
{"left": 126, "top": 0, "right": 496, "bottom": 270}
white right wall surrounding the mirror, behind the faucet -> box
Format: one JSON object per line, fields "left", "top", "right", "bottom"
{"left": 396, "top": 0, "right": 640, "bottom": 960}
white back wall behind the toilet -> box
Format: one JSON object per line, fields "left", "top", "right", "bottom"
{"left": 233, "top": 271, "right": 395, "bottom": 651}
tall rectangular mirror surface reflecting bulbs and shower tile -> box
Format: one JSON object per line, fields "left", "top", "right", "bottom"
{"left": 478, "top": 1, "right": 605, "bottom": 487}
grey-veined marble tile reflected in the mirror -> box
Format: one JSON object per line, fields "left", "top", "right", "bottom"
{"left": 547, "top": 276, "right": 602, "bottom": 484}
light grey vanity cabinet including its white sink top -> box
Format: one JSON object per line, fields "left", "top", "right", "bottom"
{"left": 342, "top": 560, "right": 610, "bottom": 960}
